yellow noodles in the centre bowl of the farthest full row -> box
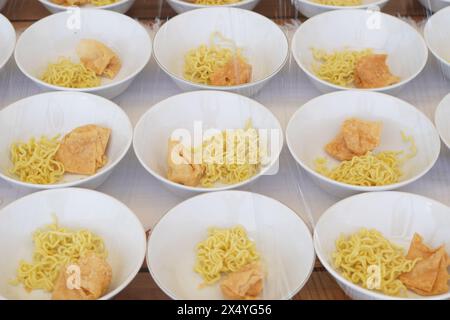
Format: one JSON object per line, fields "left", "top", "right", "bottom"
{"left": 184, "top": 32, "right": 245, "bottom": 85}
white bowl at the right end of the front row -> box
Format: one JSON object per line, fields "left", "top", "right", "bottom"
{"left": 314, "top": 191, "right": 450, "bottom": 300}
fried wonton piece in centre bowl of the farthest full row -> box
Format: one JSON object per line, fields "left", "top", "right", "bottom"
{"left": 210, "top": 57, "right": 252, "bottom": 86}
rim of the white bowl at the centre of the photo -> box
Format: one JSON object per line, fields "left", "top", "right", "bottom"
{"left": 133, "top": 90, "right": 284, "bottom": 193}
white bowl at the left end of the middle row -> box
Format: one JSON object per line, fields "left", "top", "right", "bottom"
{"left": 0, "top": 92, "right": 133, "bottom": 190}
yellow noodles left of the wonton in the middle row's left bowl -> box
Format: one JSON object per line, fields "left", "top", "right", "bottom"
{"left": 10, "top": 136, "right": 64, "bottom": 184}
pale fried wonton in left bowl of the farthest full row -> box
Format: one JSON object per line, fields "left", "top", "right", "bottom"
{"left": 77, "top": 39, "right": 122, "bottom": 79}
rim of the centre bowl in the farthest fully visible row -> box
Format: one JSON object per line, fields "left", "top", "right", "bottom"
{"left": 153, "top": 6, "right": 290, "bottom": 91}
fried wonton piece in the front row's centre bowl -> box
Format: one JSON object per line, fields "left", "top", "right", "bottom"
{"left": 220, "top": 263, "right": 264, "bottom": 300}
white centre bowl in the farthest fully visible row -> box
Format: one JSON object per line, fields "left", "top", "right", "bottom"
{"left": 153, "top": 7, "right": 289, "bottom": 96}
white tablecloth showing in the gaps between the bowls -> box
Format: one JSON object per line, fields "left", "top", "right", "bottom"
{"left": 0, "top": 19, "right": 450, "bottom": 229}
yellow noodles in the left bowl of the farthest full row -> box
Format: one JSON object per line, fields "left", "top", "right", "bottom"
{"left": 41, "top": 58, "right": 101, "bottom": 88}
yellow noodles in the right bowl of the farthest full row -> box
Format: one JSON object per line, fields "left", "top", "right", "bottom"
{"left": 312, "top": 48, "right": 373, "bottom": 87}
